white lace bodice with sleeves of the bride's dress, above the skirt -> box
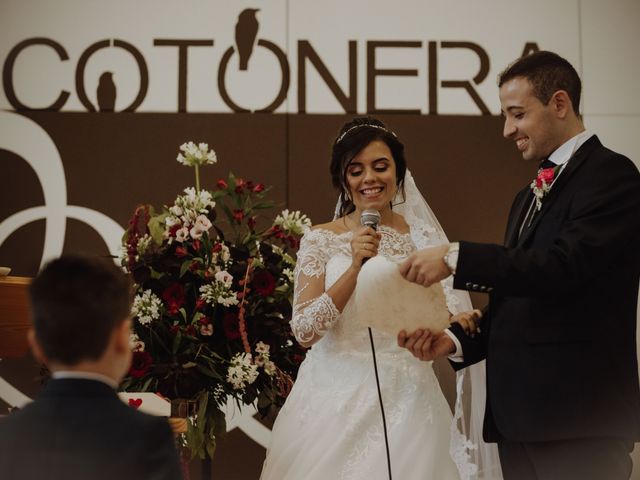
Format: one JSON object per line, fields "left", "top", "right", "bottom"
{"left": 291, "top": 226, "right": 415, "bottom": 353}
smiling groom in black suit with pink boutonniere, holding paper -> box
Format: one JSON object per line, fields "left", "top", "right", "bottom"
{"left": 398, "top": 52, "right": 640, "bottom": 480}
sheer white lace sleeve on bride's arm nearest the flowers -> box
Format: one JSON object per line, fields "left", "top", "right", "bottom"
{"left": 291, "top": 230, "right": 340, "bottom": 344}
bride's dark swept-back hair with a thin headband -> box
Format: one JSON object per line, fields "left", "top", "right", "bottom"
{"left": 329, "top": 117, "right": 407, "bottom": 217}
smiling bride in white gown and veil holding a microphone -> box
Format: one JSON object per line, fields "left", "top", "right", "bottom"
{"left": 260, "top": 118, "right": 500, "bottom": 480}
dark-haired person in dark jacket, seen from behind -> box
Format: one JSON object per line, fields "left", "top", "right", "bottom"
{"left": 0, "top": 256, "right": 182, "bottom": 480}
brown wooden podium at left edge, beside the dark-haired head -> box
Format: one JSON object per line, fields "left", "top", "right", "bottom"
{"left": 0, "top": 277, "right": 31, "bottom": 358}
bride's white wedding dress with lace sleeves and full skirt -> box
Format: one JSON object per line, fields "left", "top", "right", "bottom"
{"left": 260, "top": 226, "right": 460, "bottom": 480}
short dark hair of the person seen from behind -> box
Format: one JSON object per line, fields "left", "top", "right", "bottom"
{"left": 29, "top": 255, "right": 133, "bottom": 365}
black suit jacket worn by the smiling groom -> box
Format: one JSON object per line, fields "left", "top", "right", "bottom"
{"left": 452, "top": 136, "right": 640, "bottom": 442}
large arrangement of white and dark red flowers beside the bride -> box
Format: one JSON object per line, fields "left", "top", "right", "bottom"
{"left": 121, "top": 142, "right": 310, "bottom": 458}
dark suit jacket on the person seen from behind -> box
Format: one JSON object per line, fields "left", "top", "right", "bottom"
{"left": 0, "top": 379, "right": 182, "bottom": 480}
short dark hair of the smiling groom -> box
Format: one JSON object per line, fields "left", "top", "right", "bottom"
{"left": 498, "top": 50, "right": 582, "bottom": 115}
